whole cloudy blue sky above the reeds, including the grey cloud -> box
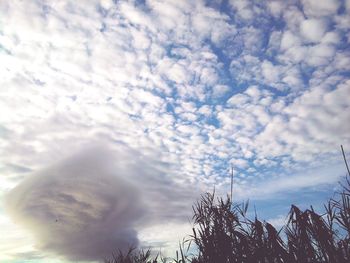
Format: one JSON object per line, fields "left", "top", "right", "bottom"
{"left": 0, "top": 0, "right": 350, "bottom": 263}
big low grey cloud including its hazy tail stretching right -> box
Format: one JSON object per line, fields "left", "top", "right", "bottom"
{"left": 6, "top": 146, "right": 197, "bottom": 260}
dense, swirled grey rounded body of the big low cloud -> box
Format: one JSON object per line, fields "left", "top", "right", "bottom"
{"left": 7, "top": 146, "right": 143, "bottom": 260}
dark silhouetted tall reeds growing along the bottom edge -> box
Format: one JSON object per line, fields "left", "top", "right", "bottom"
{"left": 106, "top": 175, "right": 350, "bottom": 263}
